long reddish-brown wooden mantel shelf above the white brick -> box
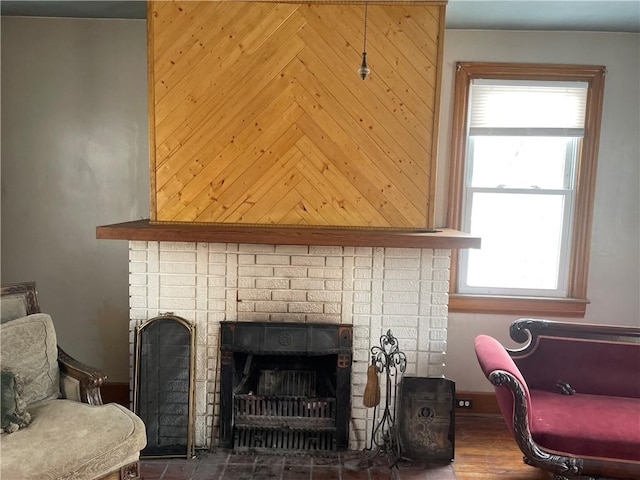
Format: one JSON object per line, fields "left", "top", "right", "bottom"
{"left": 96, "top": 220, "right": 480, "bottom": 249}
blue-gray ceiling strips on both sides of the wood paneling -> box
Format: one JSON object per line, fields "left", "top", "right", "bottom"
{"left": 0, "top": 0, "right": 640, "bottom": 33}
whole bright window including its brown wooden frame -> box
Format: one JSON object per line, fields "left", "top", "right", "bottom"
{"left": 449, "top": 63, "right": 604, "bottom": 317}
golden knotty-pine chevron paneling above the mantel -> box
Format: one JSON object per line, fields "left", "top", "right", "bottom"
{"left": 148, "top": 1, "right": 444, "bottom": 228}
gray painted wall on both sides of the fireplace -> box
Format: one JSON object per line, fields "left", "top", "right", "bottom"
{"left": 2, "top": 18, "right": 640, "bottom": 391}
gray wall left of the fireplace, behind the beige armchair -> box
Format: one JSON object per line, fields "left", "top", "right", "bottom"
{"left": 1, "top": 17, "right": 149, "bottom": 382}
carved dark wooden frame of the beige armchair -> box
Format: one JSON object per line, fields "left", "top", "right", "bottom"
{"left": 0, "top": 282, "right": 141, "bottom": 480}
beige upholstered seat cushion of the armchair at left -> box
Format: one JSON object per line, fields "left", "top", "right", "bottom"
{"left": 0, "top": 399, "right": 146, "bottom": 480}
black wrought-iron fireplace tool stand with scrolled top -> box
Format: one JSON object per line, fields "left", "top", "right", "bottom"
{"left": 360, "top": 330, "right": 407, "bottom": 468}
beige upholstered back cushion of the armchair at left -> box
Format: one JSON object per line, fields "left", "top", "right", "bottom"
{"left": 0, "top": 313, "right": 60, "bottom": 407}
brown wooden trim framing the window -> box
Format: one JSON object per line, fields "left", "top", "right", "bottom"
{"left": 447, "top": 62, "right": 606, "bottom": 318}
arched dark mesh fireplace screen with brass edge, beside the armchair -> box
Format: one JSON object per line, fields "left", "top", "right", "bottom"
{"left": 134, "top": 315, "right": 195, "bottom": 457}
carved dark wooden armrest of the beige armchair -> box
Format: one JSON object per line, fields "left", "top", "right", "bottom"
{"left": 58, "top": 347, "right": 107, "bottom": 405}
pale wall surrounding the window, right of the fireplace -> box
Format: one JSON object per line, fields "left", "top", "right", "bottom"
{"left": 436, "top": 30, "right": 640, "bottom": 391}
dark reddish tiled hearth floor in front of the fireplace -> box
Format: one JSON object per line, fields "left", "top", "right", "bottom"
{"left": 140, "top": 449, "right": 456, "bottom": 480}
